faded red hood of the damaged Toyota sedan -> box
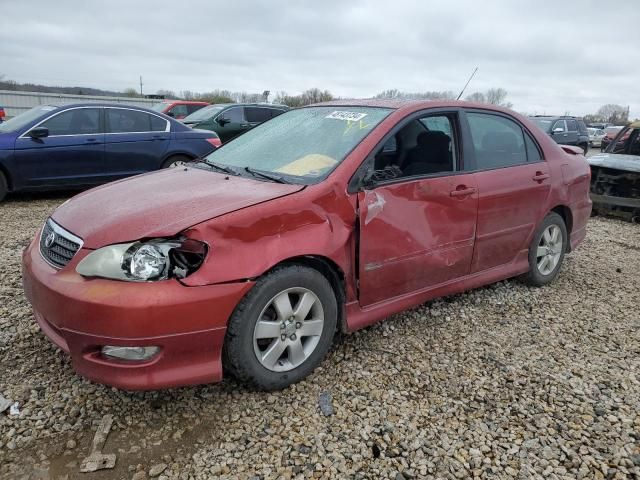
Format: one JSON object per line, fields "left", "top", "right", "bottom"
{"left": 52, "top": 168, "right": 304, "bottom": 248}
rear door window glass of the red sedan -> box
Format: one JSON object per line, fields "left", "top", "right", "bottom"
{"left": 467, "top": 113, "right": 527, "bottom": 170}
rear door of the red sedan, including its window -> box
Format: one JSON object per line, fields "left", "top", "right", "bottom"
{"left": 466, "top": 111, "right": 551, "bottom": 273}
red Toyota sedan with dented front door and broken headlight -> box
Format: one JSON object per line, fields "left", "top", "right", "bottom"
{"left": 23, "top": 100, "right": 591, "bottom": 390}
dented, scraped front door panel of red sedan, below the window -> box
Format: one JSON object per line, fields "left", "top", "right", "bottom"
{"left": 358, "top": 174, "right": 478, "bottom": 306}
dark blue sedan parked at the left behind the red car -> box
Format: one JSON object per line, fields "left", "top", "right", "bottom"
{"left": 0, "top": 103, "right": 220, "bottom": 200}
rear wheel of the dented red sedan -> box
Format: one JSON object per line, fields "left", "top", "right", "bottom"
{"left": 524, "top": 212, "right": 569, "bottom": 287}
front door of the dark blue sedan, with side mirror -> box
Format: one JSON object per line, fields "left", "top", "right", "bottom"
{"left": 15, "top": 107, "right": 105, "bottom": 187}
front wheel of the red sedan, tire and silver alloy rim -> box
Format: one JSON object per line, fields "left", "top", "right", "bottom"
{"left": 223, "top": 265, "right": 338, "bottom": 390}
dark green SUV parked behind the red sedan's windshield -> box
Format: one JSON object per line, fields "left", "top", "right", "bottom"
{"left": 182, "top": 103, "right": 289, "bottom": 143}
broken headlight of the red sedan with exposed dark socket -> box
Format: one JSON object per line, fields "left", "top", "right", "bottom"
{"left": 76, "top": 238, "right": 207, "bottom": 282}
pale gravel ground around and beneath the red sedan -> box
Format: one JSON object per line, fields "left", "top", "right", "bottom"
{"left": 0, "top": 195, "right": 640, "bottom": 480}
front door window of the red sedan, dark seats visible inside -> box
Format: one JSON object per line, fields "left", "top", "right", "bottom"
{"left": 372, "top": 114, "right": 457, "bottom": 181}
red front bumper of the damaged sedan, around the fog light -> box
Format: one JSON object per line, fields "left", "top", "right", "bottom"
{"left": 22, "top": 241, "right": 253, "bottom": 390}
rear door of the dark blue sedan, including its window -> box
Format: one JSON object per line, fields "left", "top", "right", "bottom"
{"left": 105, "top": 107, "right": 171, "bottom": 179}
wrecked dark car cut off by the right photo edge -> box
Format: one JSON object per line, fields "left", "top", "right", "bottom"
{"left": 589, "top": 122, "right": 640, "bottom": 223}
